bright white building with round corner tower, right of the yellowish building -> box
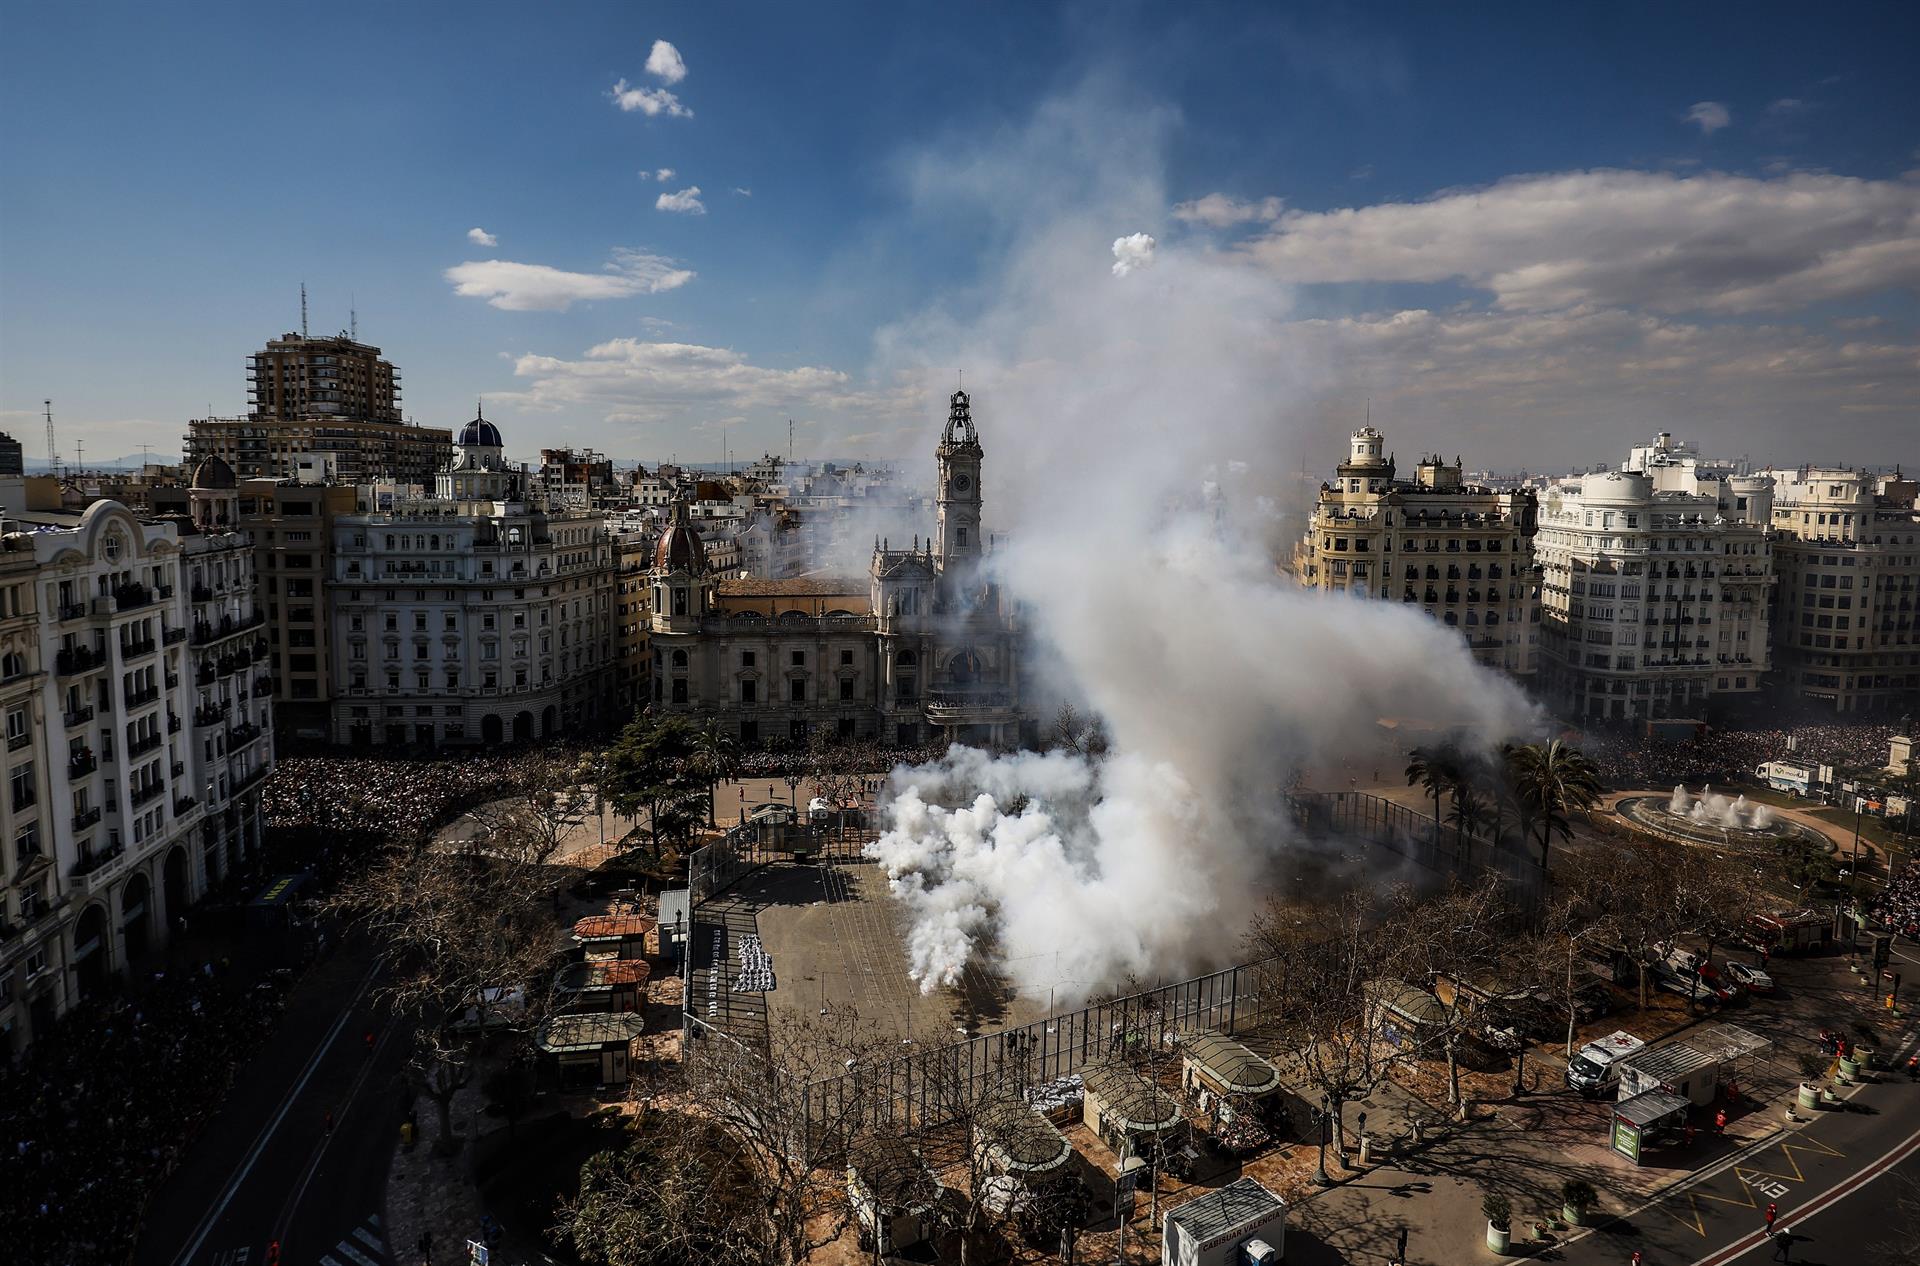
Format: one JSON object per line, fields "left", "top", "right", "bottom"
{"left": 1534, "top": 445, "right": 1774, "bottom": 720}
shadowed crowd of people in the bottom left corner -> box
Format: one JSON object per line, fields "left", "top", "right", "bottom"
{"left": 0, "top": 962, "right": 286, "bottom": 1266}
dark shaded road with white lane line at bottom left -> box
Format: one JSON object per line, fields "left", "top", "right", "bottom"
{"left": 132, "top": 945, "right": 411, "bottom": 1266}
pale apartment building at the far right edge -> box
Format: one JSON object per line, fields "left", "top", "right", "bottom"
{"left": 1772, "top": 467, "right": 1920, "bottom": 717}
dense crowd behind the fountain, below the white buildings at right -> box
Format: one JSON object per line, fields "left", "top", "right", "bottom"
{"left": 1576, "top": 724, "right": 1899, "bottom": 788}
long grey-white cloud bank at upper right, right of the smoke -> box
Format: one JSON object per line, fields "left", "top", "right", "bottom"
{"left": 1242, "top": 171, "right": 1920, "bottom": 313}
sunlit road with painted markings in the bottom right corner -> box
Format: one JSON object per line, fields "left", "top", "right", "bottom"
{"left": 1557, "top": 1039, "right": 1920, "bottom": 1266}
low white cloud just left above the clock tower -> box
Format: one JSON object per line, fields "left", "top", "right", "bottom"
{"left": 493, "top": 338, "right": 924, "bottom": 432}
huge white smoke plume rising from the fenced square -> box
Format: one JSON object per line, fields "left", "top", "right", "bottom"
{"left": 872, "top": 79, "right": 1534, "bottom": 995}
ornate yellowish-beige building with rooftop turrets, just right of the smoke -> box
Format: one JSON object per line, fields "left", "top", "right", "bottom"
{"left": 1292, "top": 426, "right": 1540, "bottom": 680}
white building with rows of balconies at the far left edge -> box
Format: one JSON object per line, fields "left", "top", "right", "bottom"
{"left": 0, "top": 495, "right": 273, "bottom": 1051}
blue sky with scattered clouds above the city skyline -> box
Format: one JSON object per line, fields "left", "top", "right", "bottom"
{"left": 0, "top": 0, "right": 1920, "bottom": 469}
